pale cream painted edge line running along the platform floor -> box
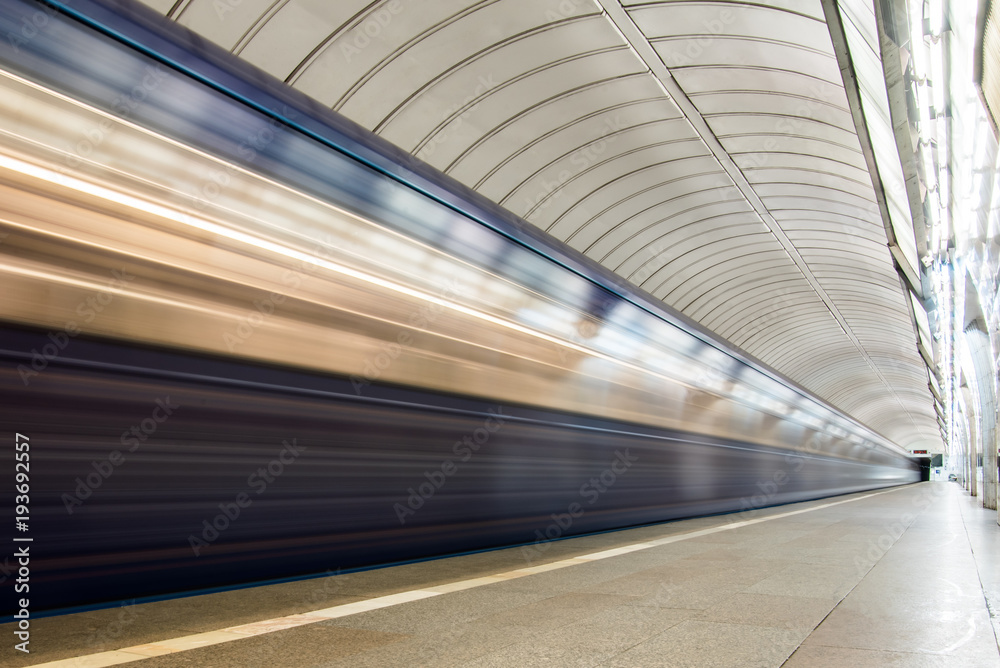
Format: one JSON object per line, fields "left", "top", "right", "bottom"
{"left": 26, "top": 485, "right": 909, "bottom": 668}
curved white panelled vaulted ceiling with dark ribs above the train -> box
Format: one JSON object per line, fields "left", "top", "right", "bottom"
{"left": 146, "top": 0, "right": 941, "bottom": 450}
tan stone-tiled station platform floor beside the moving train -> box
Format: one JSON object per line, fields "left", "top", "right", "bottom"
{"left": 7, "top": 482, "right": 1000, "bottom": 668}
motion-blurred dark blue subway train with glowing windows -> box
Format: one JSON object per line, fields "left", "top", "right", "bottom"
{"left": 0, "top": 0, "right": 919, "bottom": 619}
